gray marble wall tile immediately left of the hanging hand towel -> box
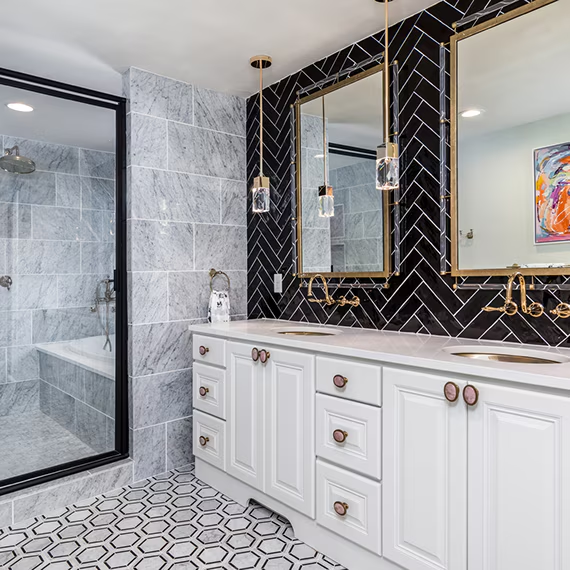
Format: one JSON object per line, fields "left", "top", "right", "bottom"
{"left": 168, "top": 271, "right": 211, "bottom": 321}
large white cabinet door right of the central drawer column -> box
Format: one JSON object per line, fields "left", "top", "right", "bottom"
{"left": 382, "top": 368, "right": 466, "bottom": 570}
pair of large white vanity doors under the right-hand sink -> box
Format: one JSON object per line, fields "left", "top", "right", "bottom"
{"left": 383, "top": 368, "right": 570, "bottom": 570}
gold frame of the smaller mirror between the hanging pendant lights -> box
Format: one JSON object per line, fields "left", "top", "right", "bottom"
{"left": 294, "top": 63, "right": 392, "bottom": 279}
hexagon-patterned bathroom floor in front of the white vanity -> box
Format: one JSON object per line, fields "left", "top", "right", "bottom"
{"left": 0, "top": 467, "right": 342, "bottom": 570}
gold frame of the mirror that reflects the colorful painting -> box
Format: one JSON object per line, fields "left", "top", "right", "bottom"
{"left": 449, "top": 0, "right": 560, "bottom": 277}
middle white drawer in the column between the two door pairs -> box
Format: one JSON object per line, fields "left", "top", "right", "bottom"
{"left": 317, "top": 394, "right": 382, "bottom": 479}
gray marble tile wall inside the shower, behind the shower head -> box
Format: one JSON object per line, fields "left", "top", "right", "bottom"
{"left": 0, "top": 135, "right": 115, "bottom": 415}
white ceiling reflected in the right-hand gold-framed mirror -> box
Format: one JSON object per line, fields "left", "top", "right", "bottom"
{"left": 458, "top": 0, "right": 570, "bottom": 138}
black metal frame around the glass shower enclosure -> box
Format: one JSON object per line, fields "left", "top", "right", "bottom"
{"left": 0, "top": 68, "right": 129, "bottom": 497}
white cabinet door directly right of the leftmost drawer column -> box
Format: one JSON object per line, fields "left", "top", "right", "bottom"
{"left": 226, "top": 342, "right": 264, "bottom": 490}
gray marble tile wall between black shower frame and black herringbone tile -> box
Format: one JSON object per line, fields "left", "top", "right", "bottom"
{"left": 124, "top": 68, "right": 247, "bottom": 480}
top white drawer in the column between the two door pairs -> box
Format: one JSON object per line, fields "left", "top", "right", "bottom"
{"left": 317, "top": 356, "right": 382, "bottom": 406}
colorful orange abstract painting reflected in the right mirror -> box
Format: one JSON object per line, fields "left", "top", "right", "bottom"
{"left": 534, "top": 143, "right": 570, "bottom": 244}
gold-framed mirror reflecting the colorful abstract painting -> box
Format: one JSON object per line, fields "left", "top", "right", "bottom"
{"left": 450, "top": 0, "right": 570, "bottom": 276}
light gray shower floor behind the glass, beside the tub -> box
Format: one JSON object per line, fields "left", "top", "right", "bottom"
{"left": 0, "top": 411, "right": 97, "bottom": 480}
